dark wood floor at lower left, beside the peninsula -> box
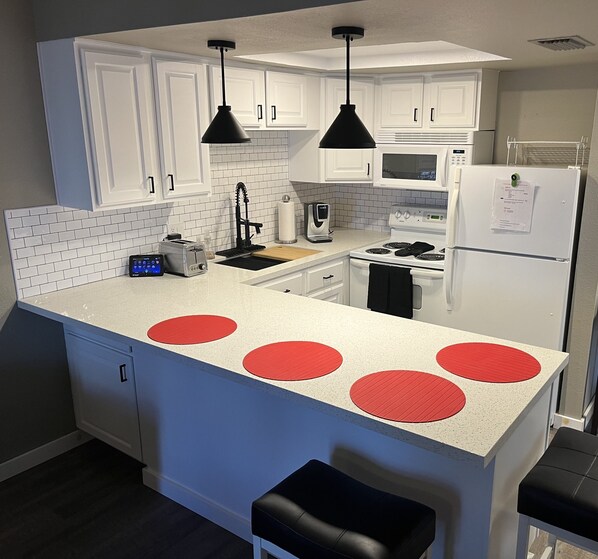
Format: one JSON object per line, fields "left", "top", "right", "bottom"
{"left": 0, "top": 440, "right": 252, "bottom": 559}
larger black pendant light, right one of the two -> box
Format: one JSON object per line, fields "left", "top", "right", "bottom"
{"left": 320, "top": 27, "right": 376, "bottom": 149}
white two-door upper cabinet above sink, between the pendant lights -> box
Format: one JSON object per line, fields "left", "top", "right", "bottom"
{"left": 210, "top": 66, "right": 319, "bottom": 129}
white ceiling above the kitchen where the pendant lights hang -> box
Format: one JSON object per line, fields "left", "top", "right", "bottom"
{"left": 85, "top": 0, "right": 598, "bottom": 72}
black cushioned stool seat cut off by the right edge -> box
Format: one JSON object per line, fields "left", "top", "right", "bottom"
{"left": 517, "top": 427, "right": 598, "bottom": 541}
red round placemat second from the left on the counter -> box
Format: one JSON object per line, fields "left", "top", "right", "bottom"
{"left": 243, "top": 341, "right": 343, "bottom": 380}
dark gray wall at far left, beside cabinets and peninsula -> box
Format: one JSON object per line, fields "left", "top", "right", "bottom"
{"left": 0, "top": 0, "right": 75, "bottom": 463}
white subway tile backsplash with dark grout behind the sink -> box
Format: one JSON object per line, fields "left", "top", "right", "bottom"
{"left": 5, "top": 131, "right": 446, "bottom": 298}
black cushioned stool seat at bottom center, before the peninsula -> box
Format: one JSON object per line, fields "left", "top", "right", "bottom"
{"left": 251, "top": 460, "right": 436, "bottom": 559}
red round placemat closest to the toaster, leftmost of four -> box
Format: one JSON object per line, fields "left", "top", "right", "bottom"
{"left": 147, "top": 314, "right": 237, "bottom": 345}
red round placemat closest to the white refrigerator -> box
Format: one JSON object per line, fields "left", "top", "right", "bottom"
{"left": 436, "top": 342, "right": 542, "bottom": 382}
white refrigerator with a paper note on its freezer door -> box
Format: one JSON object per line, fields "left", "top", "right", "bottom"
{"left": 444, "top": 165, "right": 581, "bottom": 350}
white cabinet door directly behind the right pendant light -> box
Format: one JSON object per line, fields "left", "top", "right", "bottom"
{"left": 324, "top": 79, "right": 374, "bottom": 182}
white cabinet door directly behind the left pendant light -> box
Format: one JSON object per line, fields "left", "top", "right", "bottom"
{"left": 211, "top": 66, "right": 266, "bottom": 128}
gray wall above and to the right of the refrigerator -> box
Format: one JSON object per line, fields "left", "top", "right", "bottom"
{"left": 494, "top": 64, "right": 598, "bottom": 418}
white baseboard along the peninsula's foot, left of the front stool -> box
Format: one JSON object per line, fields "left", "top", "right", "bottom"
{"left": 142, "top": 467, "right": 253, "bottom": 543}
